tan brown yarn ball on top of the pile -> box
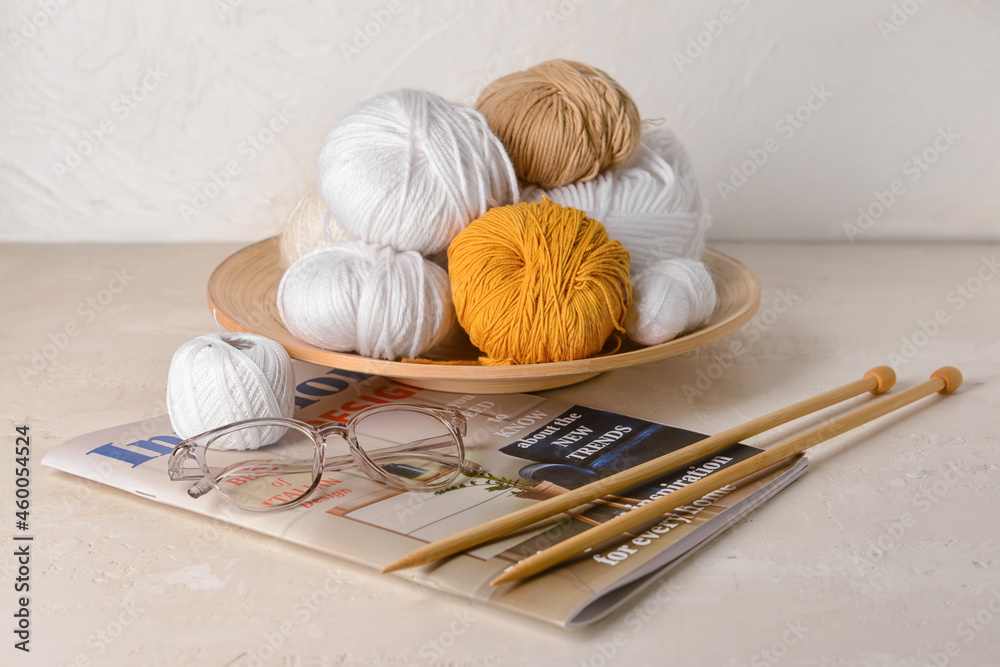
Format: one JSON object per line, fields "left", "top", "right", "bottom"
{"left": 476, "top": 60, "right": 641, "bottom": 188}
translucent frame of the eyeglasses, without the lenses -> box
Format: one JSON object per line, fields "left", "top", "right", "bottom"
{"left": 167, "top": 403, "right": 484, "bottom": 512}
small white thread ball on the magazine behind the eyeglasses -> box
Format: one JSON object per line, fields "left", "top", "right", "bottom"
{"left": 167, "top": 333, "right": 295, "bottom": 449}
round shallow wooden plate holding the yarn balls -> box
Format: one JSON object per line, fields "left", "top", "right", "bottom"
{"left": 208, "top": 238, "right": 760, "bottom": 394}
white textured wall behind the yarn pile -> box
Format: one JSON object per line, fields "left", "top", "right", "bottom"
{"left": 0, "top": 0, "right": 1000, "bottom": 241}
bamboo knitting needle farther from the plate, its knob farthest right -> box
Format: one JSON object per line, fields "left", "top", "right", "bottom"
{"left": 490, "top": 366, "right": 962, "bottom": 586}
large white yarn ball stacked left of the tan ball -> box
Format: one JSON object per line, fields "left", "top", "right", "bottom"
{"left": 319, "top": 90, "right": 518, "bottom": 255}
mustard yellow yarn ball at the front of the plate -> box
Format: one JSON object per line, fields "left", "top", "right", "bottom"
{"left": 448, "top": 200, "right": 632, "bottom": 365}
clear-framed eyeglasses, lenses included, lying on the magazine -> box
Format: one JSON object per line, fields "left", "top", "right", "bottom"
{"left": 168, "top": 404, "right": 483, "bottom": 512}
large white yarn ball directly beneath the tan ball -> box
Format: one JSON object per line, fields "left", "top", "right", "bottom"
{"left": 521, "top": 127, "right": 711, "bottom": 274}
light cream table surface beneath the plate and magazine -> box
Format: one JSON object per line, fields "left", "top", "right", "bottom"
{"left": 0, "top": 244, "right": 1000, "bottom": 667}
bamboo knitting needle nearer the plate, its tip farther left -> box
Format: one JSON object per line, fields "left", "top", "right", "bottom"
{"left": 382, "top": 366, "right": 896, "bottom": 572}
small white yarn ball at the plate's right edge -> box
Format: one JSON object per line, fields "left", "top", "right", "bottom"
{"left": 625, "top": 258, "right": 716, "bottom": 345}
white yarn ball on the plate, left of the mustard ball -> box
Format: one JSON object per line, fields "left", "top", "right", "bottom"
{"left": 278, "top": 240, "right": 455, "bottom": 360}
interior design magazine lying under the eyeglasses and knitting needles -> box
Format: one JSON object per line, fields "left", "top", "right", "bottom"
{"left": 42, "top": 361, "right": 806, "bottom": 627}
